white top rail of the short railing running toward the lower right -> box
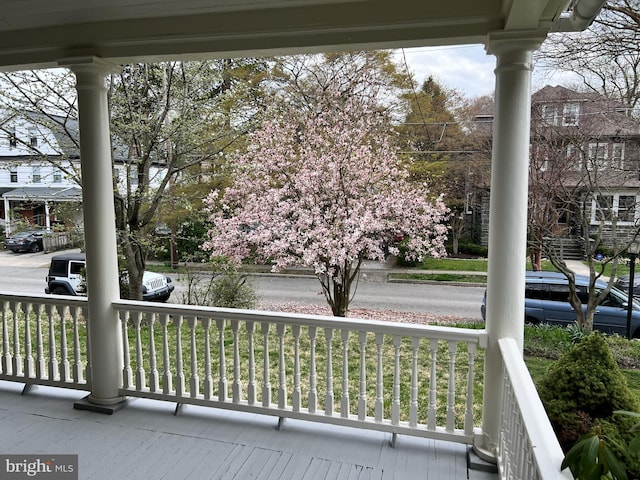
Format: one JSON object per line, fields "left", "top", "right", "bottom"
{"left": 498, "top": 338, "right": 573, "bottom": 480}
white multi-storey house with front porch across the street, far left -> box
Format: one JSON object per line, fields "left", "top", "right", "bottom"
{"left": 0, "top": 112, "right": 166, "bottom": 235}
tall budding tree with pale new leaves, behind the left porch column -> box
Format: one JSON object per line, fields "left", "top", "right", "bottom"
{"left": 4, "top": 59, "right": 266, "bottom": 299}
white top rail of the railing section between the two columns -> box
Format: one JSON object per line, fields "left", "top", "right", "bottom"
{"left": 114, "top": 300, "right": 487, "bottom": 347}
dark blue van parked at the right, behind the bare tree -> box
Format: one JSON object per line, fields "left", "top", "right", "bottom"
{"left": 480, "top": 272, "right": 640, "bottom": 338}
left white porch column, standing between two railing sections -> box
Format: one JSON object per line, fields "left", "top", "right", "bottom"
{"left": 64, "top": 57, "right": 124, "bottom": 411}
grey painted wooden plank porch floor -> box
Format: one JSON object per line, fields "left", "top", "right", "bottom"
{"left": 0, "top": 381, "right": 497, "bottom": 480}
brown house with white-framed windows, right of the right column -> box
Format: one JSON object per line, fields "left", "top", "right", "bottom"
{"left": 472, "top": 86, "right": 640, "bottom": 254}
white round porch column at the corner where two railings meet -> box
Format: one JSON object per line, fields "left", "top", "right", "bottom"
{"left": 476, "top": 32, "right": 544, "bottom": 456}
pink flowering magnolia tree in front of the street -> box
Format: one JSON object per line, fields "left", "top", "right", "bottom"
{"left": 203, "top": 89, "right": 447, "bottom": 316}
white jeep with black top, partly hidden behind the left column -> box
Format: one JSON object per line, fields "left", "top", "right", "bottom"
{"left": 44, "top": 253, "right": 175, "bottom": 302}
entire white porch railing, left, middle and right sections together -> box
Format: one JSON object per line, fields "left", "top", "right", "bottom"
{"left": 0, "top": 295, "right": 571, "bottom": 479}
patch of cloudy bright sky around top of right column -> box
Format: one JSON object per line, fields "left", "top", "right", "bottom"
{"left": 396, "top": 45, "right": 573, "bottom": 98}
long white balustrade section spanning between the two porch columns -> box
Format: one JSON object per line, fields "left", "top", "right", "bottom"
{"left": 116, "top": 301, "right": 486, "bottom": 443}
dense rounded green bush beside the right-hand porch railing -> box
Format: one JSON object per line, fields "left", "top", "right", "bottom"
{"left": 538, "top": 333, "right": 640, "bottom": 472}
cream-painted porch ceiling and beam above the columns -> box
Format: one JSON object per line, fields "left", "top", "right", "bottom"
{"left": 0, "top": 0, "right": 569, "bottom": 70}
